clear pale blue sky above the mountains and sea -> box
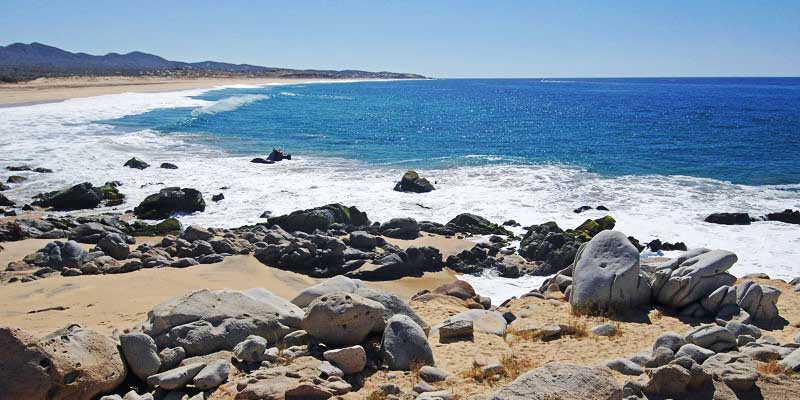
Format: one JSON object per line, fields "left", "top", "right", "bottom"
{"left": 0, "top": 0, "right": 800, "bottom": 77}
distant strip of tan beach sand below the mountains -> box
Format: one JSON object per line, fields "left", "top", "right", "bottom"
{"left": 0, "top": 76, "right": 338, "bottom": 107}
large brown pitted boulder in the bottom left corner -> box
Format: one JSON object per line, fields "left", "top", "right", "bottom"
{"left": 0, "top": 324, "right": 126, "bottom": 400}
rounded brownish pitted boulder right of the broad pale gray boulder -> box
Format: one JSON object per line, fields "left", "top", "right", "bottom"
{"left": 302, "top": 292, "right": 385, "bottom": 346}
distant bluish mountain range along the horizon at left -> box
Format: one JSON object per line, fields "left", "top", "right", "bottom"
{"left": 0, "top": 42, "right": 424, "bottom": 82}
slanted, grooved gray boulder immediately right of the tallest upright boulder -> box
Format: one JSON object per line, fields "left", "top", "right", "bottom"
{"left": 652, "top": 250, "right": 737, "bottom": 308}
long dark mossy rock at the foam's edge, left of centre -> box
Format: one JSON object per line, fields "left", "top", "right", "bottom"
{"left": 266, "top": 204, "right": 370, "bottom": 233}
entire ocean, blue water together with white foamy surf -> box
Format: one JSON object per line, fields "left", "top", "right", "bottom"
{"left": 0, "top": 78, "right": 800, "bottom": 296}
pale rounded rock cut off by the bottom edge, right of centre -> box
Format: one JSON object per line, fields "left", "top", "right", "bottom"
{"left": 488, "top": 363, "right": 622, "bottom": 400}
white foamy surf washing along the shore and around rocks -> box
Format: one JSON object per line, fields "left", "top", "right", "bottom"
{"left": 0, "top": 86, "right": 800, "bottom": 300}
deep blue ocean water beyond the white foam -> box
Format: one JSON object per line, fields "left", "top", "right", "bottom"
{"left": 105, "top": 78, "right": 800, "bottom": 185}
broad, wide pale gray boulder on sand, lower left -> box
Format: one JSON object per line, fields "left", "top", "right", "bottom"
{"left": 144, "top": 288, "right": 303, "bottom": 356}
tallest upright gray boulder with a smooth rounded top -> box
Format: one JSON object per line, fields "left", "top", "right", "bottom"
{"left": 570, "top": 230, "right": 650, "bottom": 312}
